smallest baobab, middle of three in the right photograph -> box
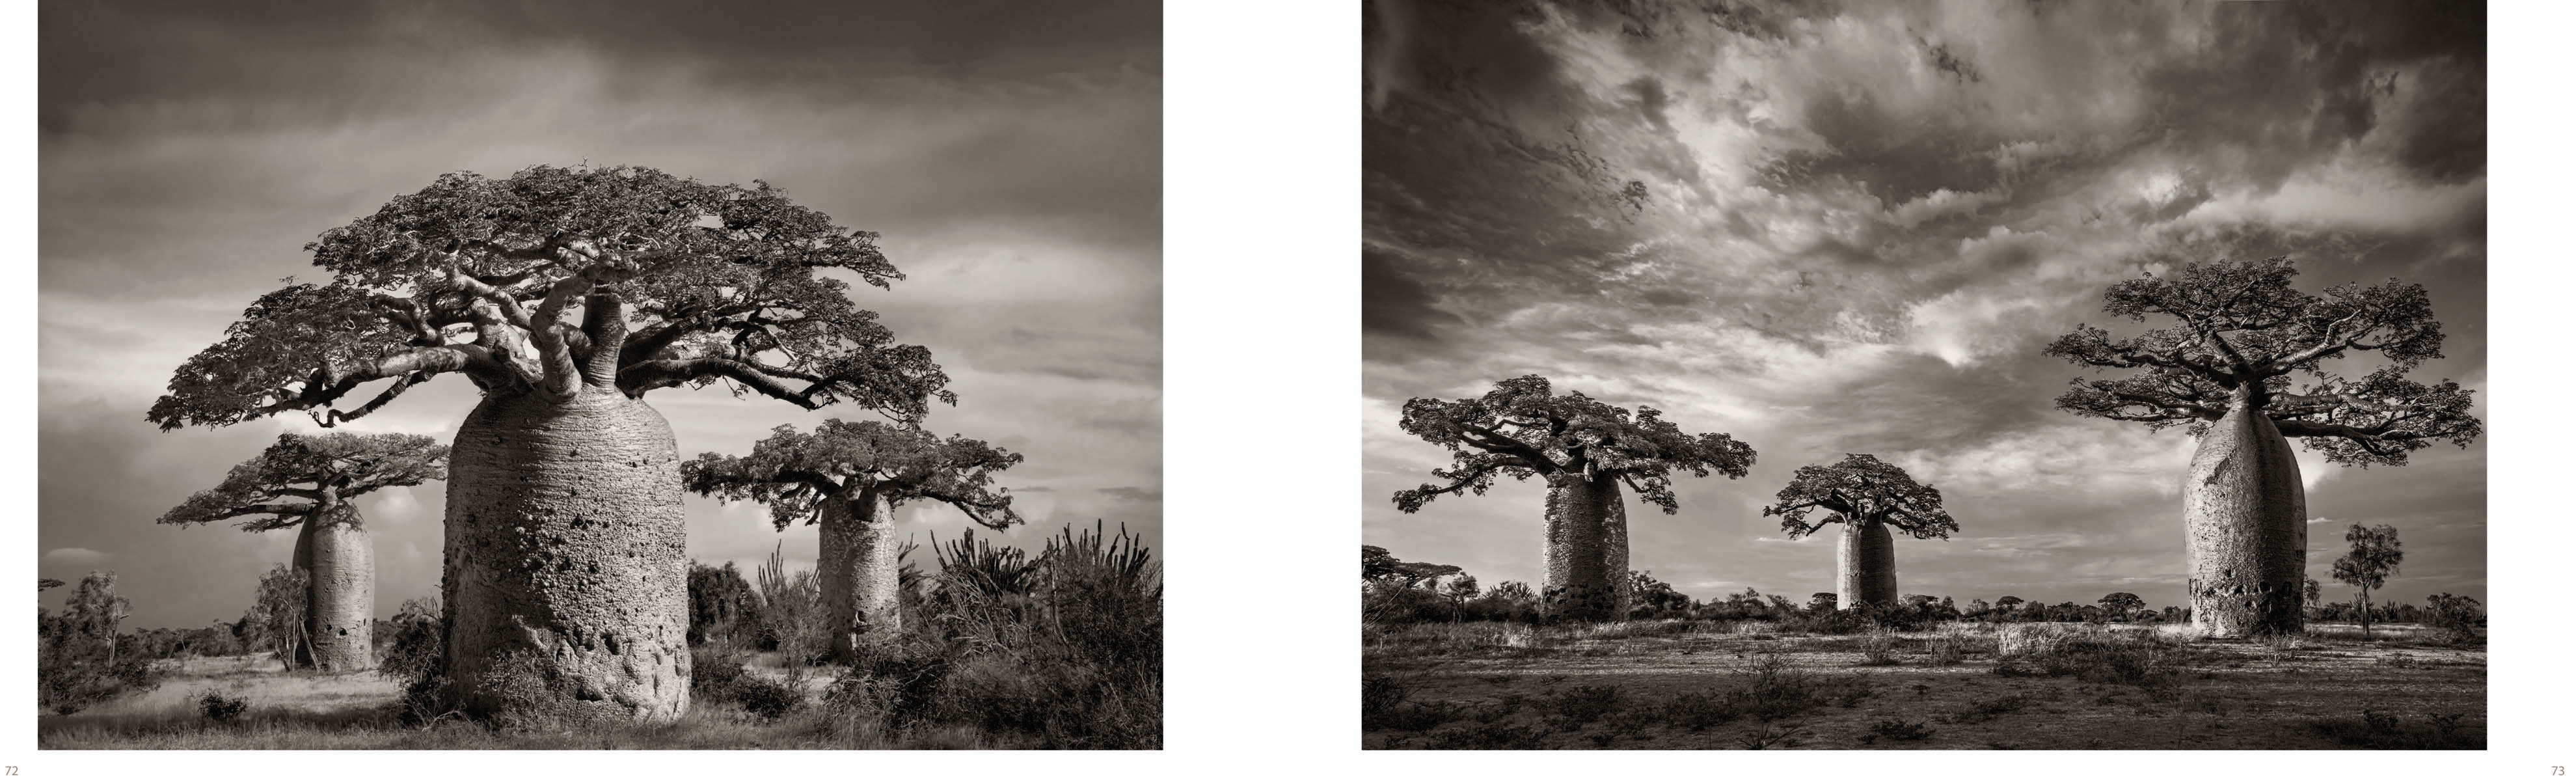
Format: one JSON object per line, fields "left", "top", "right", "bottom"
{"left": 1762, "top": 454, "right": 1958, "bottom": 609}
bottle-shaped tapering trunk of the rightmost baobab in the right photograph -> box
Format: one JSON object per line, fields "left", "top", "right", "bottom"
{"left": 2182, "top": 397, "right": 2308, "bottom": 637}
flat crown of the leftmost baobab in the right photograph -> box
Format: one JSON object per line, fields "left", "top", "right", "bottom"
{"left": 1396, "top": 374, "right": 1754, "bottom": 515}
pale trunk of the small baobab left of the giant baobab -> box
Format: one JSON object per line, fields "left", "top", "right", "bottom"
{"left": 296, "top": 505, "right": 376, "bottom": 673}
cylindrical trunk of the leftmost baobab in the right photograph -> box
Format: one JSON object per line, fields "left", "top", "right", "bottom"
{"left": 1545, "top": 474, "right": 1631, "bottom": 621}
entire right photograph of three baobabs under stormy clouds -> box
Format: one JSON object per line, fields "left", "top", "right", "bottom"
{"left": 1357, "top": 0, "right": 2488, "bottom": 750}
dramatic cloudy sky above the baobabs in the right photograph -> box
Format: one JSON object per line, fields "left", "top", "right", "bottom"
{"left": 1360, "top": 0, "right": 2486, "bottom": 606}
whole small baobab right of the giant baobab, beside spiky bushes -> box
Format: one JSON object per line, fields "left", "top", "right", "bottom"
{"left": 680, "top": 420, "right": 1020, "bottom": 660}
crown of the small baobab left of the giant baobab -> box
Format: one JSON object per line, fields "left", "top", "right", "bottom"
{"left": 159, "top": 433, "right": 448, "bottom": 531}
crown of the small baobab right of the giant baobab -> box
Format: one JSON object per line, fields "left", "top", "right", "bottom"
{"left": 680, "top": 420, "right": 1020, "bottom": 531}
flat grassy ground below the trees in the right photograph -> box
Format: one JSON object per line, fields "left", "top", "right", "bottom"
{"left": 1363, "top": 621, "right": 2486, "bottom": 750}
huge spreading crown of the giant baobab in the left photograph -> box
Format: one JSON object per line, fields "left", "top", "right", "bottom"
{"left": 147, "top": 165, "right": 956, "bottom": 430}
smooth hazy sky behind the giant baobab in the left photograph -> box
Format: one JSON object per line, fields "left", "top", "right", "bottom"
{"left": 38, "top": 3, "right": 1162, "bottom": 626}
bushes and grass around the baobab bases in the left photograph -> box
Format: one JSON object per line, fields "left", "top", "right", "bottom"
{"left": 36, "top": 526, "right": 1162, "bottom": 750}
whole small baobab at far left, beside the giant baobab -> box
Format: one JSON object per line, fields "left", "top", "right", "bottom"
{"left": 159, "top": 433, "right": 448, "bottom": 673}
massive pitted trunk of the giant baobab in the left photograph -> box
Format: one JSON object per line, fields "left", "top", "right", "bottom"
{"left": 441, "top": 387, "right": 690, "bottom": 724}
